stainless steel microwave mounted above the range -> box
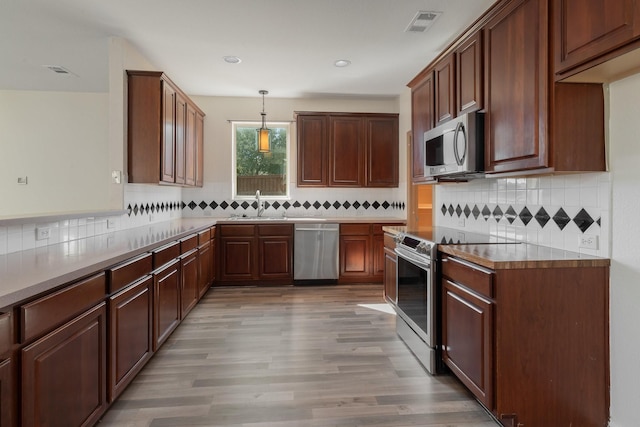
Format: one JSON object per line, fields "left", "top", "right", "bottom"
{"left": 424, "top": 111, "right": 484, "bottom": 179}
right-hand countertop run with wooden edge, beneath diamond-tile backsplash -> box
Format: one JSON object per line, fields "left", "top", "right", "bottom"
{"left": 383, "top": 226, "right": 610, "bottom": 270}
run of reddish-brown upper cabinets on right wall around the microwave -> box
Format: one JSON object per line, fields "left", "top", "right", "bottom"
{"left": 408, "top": 0, "right": 608, "bottom": 182}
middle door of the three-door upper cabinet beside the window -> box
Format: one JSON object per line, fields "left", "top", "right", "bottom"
{"left": 329, "top": 116, "right": 364, "bottom": 187}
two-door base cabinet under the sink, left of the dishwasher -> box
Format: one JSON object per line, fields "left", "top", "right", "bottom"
{"left": 218, "top": 224, "right": 293, "bottom": 285}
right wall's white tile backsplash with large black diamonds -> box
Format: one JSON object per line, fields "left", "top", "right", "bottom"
{"left": 433, "top": 172, "right": 611, "bottom": 257}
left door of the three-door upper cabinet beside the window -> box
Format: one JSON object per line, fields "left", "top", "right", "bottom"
{"left": 297, "top": 115, "right": 329, "bottom": 187}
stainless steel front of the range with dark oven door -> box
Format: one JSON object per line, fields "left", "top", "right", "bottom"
{"left": 395, "top": 233, "right": 440, "bottom": 375}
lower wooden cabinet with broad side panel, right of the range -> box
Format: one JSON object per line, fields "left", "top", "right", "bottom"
{"left": 440, "top": 249, "right": 609, "bottom": 427}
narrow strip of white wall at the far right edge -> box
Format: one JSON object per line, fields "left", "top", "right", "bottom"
{"left": 609, "top": 74, "right": 640, "bottom": 427}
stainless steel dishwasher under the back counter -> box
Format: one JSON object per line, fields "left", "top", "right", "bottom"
{"left": 293, "top": 222, "right": 340, "bottom": 284}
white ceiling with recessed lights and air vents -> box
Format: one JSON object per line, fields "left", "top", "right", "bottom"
{"left": 0, "top": 0, "right": 495, "bottom": 98}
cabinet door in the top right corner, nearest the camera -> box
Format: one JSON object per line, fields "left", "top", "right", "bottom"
{"left": 553, "top": 0, "right": 640, "bottom": 74}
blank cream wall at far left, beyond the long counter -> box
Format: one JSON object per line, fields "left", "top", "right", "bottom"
{"left": 0, "top": 91, "right": 109, "bottom": 218}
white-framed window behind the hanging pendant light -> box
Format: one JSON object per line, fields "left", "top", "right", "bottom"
{"left": 232, "top": 122, "right": 289, "bottom": 199}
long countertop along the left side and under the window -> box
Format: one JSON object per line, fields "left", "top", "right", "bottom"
{"left": 0, "top": 217, "right": 405, "bottom": 308}
